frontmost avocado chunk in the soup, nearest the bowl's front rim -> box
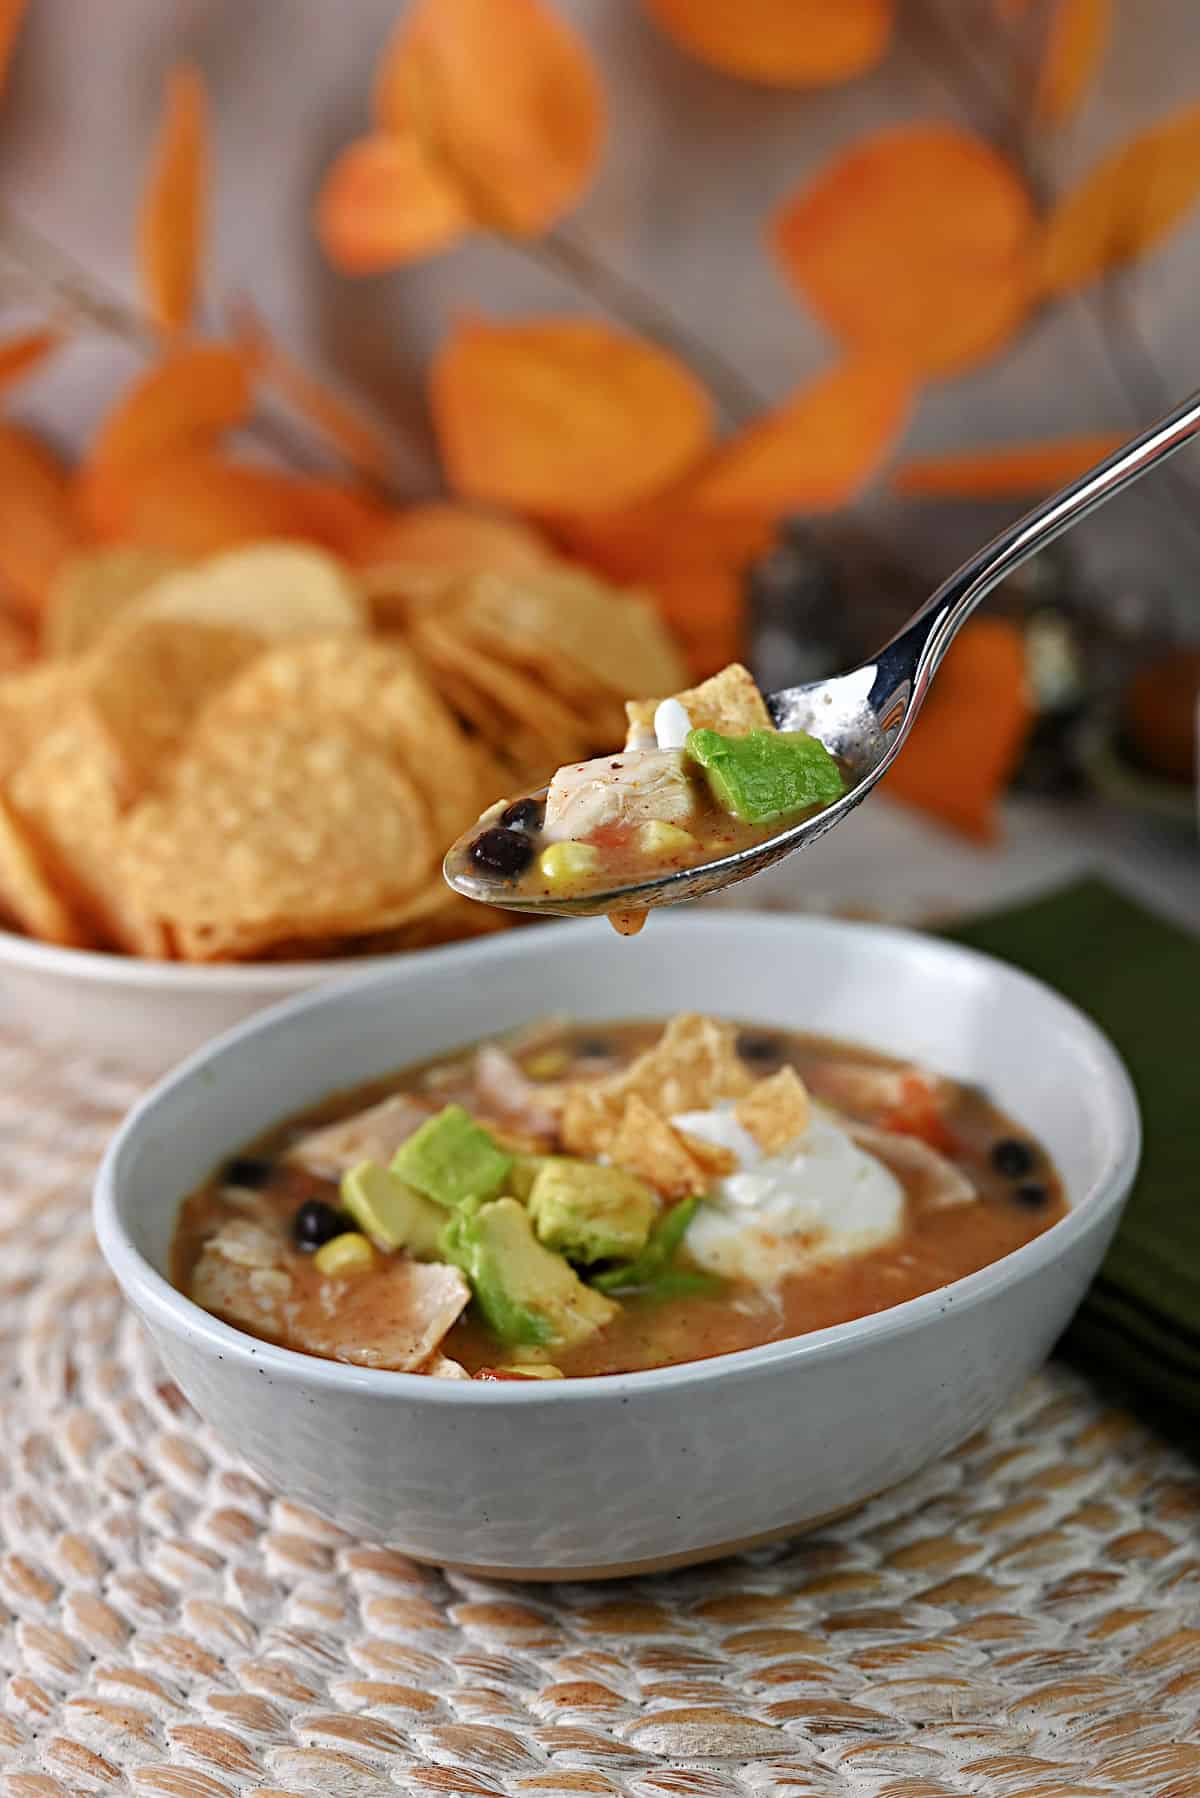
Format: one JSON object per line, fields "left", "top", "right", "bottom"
{"left": 443, "top": 1197, "right": 621, "bottom": 1349}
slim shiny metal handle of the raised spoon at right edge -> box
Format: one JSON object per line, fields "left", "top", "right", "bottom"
{"left": 876, "top": 392, "right": 1200, "bottom": 701}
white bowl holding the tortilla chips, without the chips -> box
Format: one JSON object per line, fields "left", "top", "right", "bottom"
{"left": 0, "top": 930, "right": 398, "bottom": 1073}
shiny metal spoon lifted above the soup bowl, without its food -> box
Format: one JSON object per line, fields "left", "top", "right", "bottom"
{"left": 443, "top": 379, "right": 1200, "bottom": 917}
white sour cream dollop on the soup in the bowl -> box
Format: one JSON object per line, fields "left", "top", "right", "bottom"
{"left": 671, "top": 1104, "right": 905, "bottom": 1286}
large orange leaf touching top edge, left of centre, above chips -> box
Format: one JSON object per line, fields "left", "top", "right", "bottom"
{"left": 374, "top": 0, "right": 604, "bottom": 235}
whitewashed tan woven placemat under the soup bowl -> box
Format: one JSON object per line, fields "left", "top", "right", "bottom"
{"left": 0, "top": 1032, "right": 1200, "bottom": 1798}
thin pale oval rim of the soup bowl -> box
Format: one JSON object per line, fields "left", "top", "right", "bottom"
{"left": 94, "top": 912, "right": 1141, "bottom": 1406}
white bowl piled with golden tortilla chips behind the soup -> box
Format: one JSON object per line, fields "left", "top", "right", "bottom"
{"left": 0, "top": 541, "right": 684, "bottom": 1064}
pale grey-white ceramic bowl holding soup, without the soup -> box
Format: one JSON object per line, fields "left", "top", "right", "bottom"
{"left": 95, "top": 912, "right": 1139, "bottom": 1579}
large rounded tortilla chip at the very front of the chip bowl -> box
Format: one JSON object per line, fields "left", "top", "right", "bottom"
{"left": 121, "top": 719, "right": 435, "bottom": 962}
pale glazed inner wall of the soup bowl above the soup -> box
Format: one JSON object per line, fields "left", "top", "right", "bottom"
{"left": 115, "top": 913, "right": 1137, "bottom": 1273}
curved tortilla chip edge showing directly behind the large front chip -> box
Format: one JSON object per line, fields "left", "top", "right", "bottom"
{"left": 196, "top": 636, "right": 488, "bottom": 849}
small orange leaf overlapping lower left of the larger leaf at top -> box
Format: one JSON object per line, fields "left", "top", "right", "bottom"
{"left": 317, "top": 131, "right": 473, "bottom": 275}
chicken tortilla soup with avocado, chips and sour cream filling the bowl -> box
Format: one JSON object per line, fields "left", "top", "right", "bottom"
{"left": 173, "top": 1014, "right": 1065, "bottom": 1379}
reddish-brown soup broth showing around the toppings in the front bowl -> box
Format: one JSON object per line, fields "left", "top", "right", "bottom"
{"left": 171, "top": 1021, "right": 1065, "bottom": 1375}
